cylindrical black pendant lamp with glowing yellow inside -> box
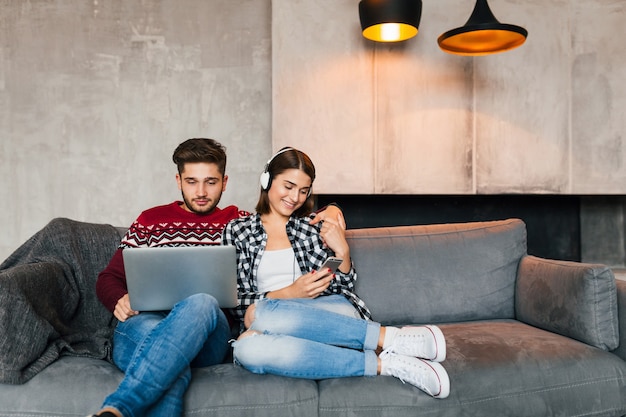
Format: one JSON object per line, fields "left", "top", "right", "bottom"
{"left": 359, "top": 0, "right": 422, "bottom": 42}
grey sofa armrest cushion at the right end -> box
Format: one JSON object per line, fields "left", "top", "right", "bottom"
{"left": 515, "top": 256, "right": 619, "bottom": 350}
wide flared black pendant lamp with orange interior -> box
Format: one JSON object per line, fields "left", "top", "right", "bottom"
{"left": 437, "top": 0, "right": 528, "bottom": 56}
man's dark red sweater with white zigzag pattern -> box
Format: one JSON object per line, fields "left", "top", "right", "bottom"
{"left": 96, "top": 201, "right": 249, "bottom": 312}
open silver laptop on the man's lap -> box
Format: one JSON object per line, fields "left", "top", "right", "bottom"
{"left": 122, "top": 245, "right": 239, "bottom": 311}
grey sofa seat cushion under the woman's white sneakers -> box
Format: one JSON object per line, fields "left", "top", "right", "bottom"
{"left": 319, "top": 320, "right": 626, "bottom": 417}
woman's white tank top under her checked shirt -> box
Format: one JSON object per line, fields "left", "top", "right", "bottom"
{"left": 257, "top": 248, "right": 302, "bottom": 292}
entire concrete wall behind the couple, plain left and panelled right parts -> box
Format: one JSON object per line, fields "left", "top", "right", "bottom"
{"left": 0, "top": 0, "right": 626, "bottom": 259}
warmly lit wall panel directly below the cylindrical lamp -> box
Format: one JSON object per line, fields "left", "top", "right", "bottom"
{"left": 370, "top": 0, "right": 474, "bottom": 194}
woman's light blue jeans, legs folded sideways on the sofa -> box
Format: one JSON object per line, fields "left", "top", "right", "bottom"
{"left": 233, "top": 295, "right": 380, "bottom": 379}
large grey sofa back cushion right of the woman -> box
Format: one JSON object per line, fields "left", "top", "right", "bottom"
{"left": 346, "top": 219, "right": 526, "bottom": 325}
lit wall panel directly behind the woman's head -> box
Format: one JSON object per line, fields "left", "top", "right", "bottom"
{"left": 272, "top": 0, "right": 376, "bottom": 194}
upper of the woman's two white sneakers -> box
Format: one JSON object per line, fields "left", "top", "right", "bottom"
{"left": 386, "top": 326, "right": 446, "bottom": 362}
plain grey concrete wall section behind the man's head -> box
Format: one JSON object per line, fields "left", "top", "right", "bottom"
{"left": 0, "top": 0, "right": 271, "bottom": 260}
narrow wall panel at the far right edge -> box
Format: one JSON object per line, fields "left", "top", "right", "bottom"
{"left": 571, "top": 0, "right": 626, "bottom": 194}
